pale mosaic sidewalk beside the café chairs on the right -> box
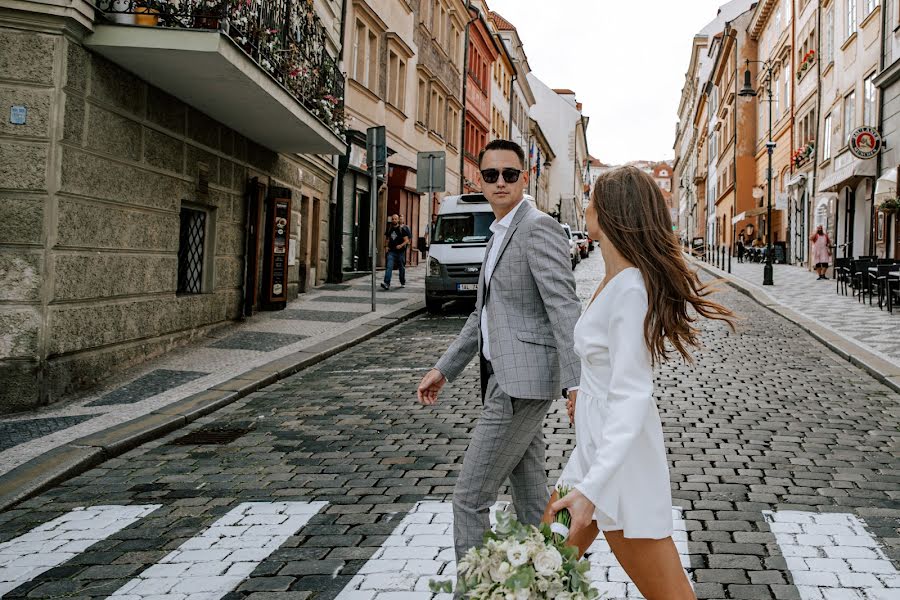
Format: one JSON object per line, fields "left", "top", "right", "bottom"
{"left": 731, "top": 260, "right": 900, "bottom": 365}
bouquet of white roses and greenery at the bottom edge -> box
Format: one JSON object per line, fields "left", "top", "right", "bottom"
{"left": 431, "top": 489, "right": 600, "bottom": 600}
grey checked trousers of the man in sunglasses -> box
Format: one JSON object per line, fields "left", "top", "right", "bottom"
{"left": 453, "top": 374, "right": 552, "bottom": 562}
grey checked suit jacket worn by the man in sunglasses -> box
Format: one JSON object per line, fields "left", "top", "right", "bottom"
{"left": 435, "top": 202, "right": 581, "bottom": 400}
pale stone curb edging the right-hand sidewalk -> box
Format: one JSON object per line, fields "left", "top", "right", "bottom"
{"left": 684, "top": 254, "right": 900, "bottom": 392}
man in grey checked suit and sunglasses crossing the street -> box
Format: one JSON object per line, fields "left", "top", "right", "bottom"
{"left": 418, "top": 140, "right": 581, "bottom": 560}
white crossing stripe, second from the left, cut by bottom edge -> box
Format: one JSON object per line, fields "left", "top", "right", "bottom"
{"left": 110, "top": 502, "right": 328, "bottom": 600}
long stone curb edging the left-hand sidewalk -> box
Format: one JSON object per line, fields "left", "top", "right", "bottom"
{"left": 0, "top": 302, "right": 428, "bottom": 511}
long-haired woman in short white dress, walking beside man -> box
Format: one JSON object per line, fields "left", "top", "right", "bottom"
{"left": 545, "top": 167, "right": 733, "bottom": 600}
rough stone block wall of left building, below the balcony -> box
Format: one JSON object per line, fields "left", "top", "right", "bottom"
{"left": 0, "top": 22, "right": 333, "bottom": 413}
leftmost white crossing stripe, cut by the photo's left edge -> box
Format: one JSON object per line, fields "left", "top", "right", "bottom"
{"left": 0, "top": 504, "right": 160, "bottom": 596}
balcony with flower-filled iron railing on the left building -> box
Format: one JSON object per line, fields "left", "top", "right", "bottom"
{"left": 86, "top": 0, "right": 345, "bottom": 154}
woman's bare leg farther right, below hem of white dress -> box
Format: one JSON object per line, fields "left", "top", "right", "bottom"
{"left": 603, "top": 531, "right": 697, "bottom": 600}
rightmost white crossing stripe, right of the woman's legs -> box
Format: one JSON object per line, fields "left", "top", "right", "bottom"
{"left": 763, "top": 510, "right": 900, "bottom": 600}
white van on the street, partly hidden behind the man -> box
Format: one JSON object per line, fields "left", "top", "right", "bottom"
{"left": 425, "top": 194, "right": 534, "bottom": 313}
